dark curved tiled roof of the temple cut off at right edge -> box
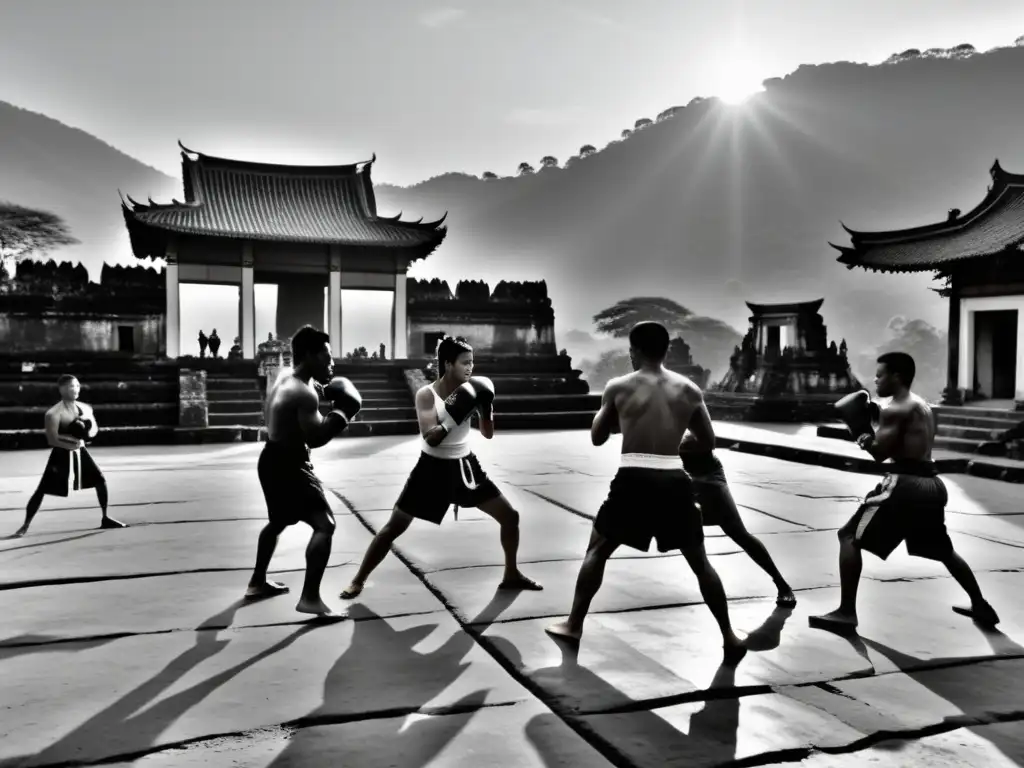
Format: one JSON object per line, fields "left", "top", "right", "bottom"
{"left": 828, "top": 160, "right": 1024, "bottom": 272}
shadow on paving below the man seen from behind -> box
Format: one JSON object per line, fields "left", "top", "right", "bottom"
{"left": 506, "top": 606, "right": 793, "bottom": 768}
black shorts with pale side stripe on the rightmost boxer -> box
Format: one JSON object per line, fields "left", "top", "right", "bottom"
{"left": 839, "top": 462, "right": 953, "bottom": 561}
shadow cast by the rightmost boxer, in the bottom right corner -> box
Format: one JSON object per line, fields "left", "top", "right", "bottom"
{"left": 863, "top": 628, "right": 1024, "bottom": 764}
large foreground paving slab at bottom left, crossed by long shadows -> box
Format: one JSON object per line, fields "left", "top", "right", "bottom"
{"left": 0, "top": 608, "right": 529, "bottom": 766}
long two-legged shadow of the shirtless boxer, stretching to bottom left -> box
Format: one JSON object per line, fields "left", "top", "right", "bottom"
{"left": 19, "top": 599, "right": 324, "bottom": 764}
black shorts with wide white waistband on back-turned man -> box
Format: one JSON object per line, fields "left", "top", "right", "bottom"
{"left": 594, "top": 454, "right": 703, "bottom": 552}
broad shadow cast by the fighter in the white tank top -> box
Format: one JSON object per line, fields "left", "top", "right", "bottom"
{"left": 270, "top": 590, "right": 518, "bottom": 768}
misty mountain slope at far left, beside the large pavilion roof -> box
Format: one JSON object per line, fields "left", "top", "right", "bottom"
{"left": 0, "top": 101, "right": 181, "bottom": 281}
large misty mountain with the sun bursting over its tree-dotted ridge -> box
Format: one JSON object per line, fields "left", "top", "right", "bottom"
{"left": 377, "top": 47, "right": 1024, "bottom": 365}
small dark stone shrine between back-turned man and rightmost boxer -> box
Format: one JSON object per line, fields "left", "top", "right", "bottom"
{"left": 716, "top": 299, "right": 863, "bottom": 421}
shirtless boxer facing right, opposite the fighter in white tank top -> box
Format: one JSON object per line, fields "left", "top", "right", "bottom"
{"left": 246, "top": 326, "right": 362, "bottom": 618}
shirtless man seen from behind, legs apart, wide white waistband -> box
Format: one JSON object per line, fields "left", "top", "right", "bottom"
{"left": 546, "top": 323, "right": 746, "bottom": 664}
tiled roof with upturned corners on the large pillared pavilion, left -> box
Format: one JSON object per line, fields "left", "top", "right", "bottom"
{"left": 122, "top": 141, "right": 447, "bottom": 256}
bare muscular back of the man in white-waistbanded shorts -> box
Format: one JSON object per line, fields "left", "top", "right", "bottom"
{"left": 608, "top": 369, "right": 702, "bottom": 456}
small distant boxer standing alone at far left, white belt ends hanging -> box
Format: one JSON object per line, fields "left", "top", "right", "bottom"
{"left": 12, "top": 374, "right": 127, "bottom": 539}
